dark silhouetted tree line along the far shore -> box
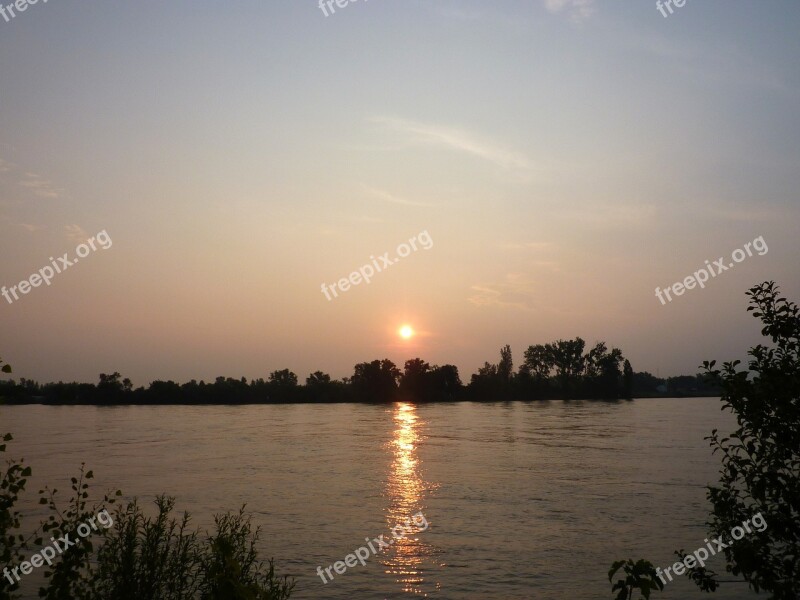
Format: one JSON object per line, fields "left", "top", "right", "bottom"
{"left": 0, "top": 337, "right": 719, "bottom": 405}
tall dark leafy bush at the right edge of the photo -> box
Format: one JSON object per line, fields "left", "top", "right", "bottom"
{"left": 612, "top": 281, "right": 800, "bottom": 600}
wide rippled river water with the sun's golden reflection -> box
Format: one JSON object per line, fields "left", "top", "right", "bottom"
{"left": 0, "top": 398, "right": 757, "bottom": 600}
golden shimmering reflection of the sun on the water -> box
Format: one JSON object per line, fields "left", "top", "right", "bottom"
{"left": 383, "top": 402, "right": 438, "bottom": 595}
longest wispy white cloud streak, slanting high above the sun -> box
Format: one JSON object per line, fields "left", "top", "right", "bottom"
{"left": 370, "top": 117, "right": 533, "bottom": 171}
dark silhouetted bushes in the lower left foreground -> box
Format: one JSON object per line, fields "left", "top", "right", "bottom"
{"left": 0, "top": 435, "right": 294, "bottom": 600}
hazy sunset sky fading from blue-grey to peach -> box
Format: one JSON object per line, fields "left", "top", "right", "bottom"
{"left": 0, "top": 0, "right": 800, "bottom": 386}
